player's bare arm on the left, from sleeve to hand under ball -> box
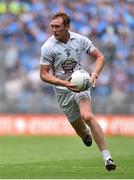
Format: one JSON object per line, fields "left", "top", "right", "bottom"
{"left": 40, "top": 65, "right": 78, "bottom": 92}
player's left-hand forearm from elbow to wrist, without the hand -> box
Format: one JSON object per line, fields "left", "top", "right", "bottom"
{"left": 40, "top": 74, "right": 66, "bottom": 86}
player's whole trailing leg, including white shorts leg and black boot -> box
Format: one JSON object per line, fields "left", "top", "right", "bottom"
{"left": 56, "top": 92, "right": 92, "bottom": 146}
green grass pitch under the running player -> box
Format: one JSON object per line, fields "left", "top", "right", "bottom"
{"left": 0, "top": 136, "right": 134, "bottom": 179}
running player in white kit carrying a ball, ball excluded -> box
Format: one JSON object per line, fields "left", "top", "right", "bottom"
{"left": 40, "top": 12, "right": 116, "bottom": 171}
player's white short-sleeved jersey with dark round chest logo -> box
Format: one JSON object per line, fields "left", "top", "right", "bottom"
{"left": 40, "top": 31, "right": 95, "bottom": 91}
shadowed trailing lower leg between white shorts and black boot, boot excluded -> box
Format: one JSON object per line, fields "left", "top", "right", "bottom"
{"left": 71, "top": 118, "right": 89, "bottom": 138}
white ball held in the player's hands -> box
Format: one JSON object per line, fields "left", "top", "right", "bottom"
{"left": 70, "top": 70, "right": 91, "bottom": 91}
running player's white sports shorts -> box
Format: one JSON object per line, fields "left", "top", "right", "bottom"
{"left": 56, "top": 90, "right": 91, "bottom": 123}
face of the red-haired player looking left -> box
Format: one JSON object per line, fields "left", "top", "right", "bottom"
{"left": 51, "top": 17, "right": 69, "bottom": 42}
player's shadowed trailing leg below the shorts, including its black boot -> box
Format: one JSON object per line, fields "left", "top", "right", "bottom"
{"left": 71, "top": 118, "right": 92, "bottom": 146}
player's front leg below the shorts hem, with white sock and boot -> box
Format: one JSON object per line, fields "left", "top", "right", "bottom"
{"left": 79, "top": 99, "right": 116, "bottom": 171}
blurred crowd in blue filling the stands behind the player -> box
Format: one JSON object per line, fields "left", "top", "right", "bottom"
{"left": 0, "top": 0, "right": 134, "bottom": 112}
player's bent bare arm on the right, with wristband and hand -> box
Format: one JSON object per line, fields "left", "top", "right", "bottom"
{"left": 90, "top": 48, "right": 105, "bottom": 87}
